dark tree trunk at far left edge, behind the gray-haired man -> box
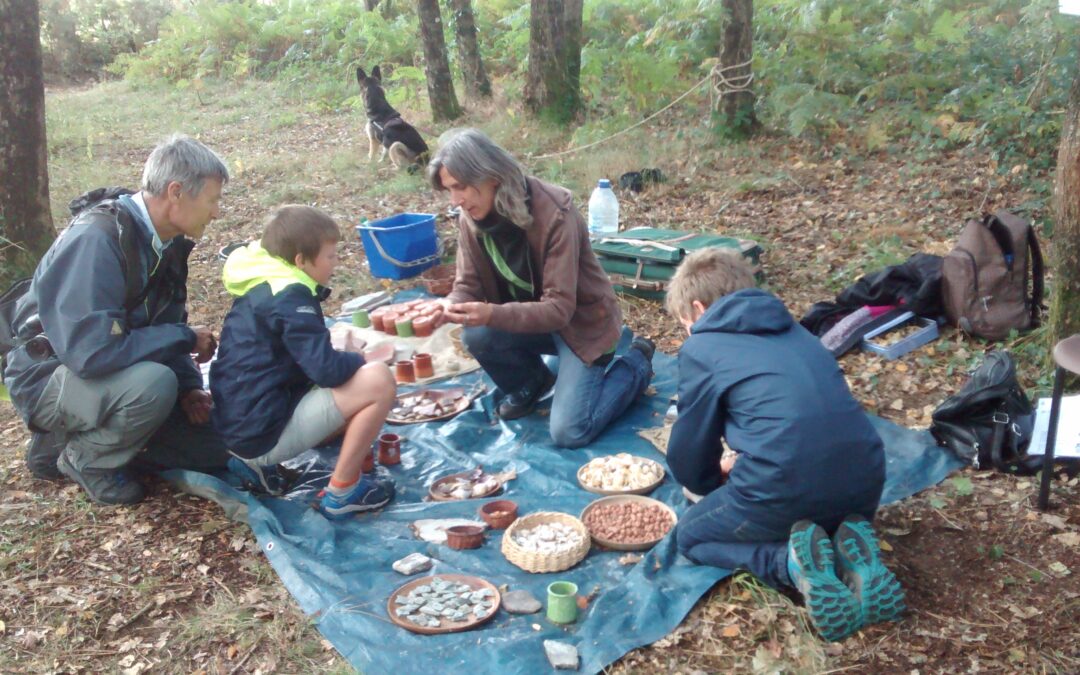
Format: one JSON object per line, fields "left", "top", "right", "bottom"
{"left": 0, "top": 0, "right": 56, "bottom": 292}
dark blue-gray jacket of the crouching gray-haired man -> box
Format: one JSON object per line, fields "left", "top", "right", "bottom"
{"left": 4, "top": 189, "right": 202, "bottom": 424}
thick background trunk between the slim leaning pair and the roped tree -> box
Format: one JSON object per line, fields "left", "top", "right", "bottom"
{"left": 525, "top": 0, "right": 582, "bottom": 123}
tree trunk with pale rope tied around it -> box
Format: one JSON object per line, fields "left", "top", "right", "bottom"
{"left": 713, "top": 0, "right": 758, "bottom": 135}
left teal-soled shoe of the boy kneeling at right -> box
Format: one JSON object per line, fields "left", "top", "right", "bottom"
{"left": 787, "top": 521, "right": 863, "bottom": 642}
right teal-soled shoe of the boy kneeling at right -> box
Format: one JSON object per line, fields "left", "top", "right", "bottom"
{"left": 833, "top": 514, "right": 906, "bottom": 625}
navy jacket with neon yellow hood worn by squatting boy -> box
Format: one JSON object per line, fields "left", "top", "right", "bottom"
{"left": 210, "top": 242, "right": 364, "bottom": 459}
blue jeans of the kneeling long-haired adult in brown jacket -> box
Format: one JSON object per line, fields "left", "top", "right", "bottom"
{"left": 462, "top": 326, "right": 652, "bottom": 448}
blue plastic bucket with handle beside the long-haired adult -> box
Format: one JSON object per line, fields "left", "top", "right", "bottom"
{"left": 356, "top": 213, "right": 438, "bottom": 279}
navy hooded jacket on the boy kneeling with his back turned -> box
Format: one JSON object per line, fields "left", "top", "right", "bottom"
{"left": 667, "top": 288, "right": 885, "bottom": 517}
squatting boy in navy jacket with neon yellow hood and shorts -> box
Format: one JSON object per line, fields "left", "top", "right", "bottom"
{"left": 210, "top": 205, "right": 396, "bottom": 517}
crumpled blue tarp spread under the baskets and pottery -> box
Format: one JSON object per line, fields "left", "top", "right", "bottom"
{"left": 165, "top": 340, "right": 961, "bottom": 675}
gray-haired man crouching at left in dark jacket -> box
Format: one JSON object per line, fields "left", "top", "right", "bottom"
{"left": 3, "top": 135, "right": 229, "bottom": 504}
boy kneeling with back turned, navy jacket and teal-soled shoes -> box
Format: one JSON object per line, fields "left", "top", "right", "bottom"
{"left": 667, "top": 248, "right": 904, "bottom": 640}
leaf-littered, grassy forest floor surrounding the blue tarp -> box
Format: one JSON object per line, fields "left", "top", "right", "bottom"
{"left": 0, "top": 78, "right": 1080, "bottom": 675}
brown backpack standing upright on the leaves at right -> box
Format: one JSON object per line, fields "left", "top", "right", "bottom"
{"left": 942, "top": 211, "right": 1043, "bottom": 340}
